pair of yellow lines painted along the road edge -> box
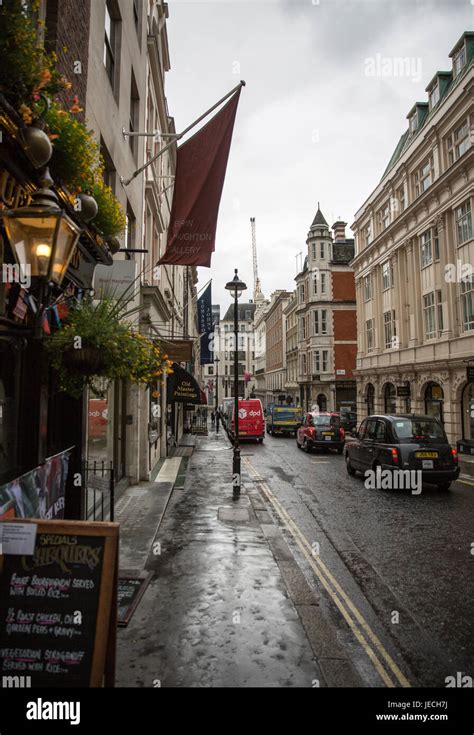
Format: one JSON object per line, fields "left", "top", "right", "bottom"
{"left": 244, "top": 458, "right": 411, "bottom": 688}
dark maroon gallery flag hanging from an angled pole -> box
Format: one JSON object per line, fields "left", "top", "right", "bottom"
{"left": 159, "top": 89, "right": 241, "bottom": 267}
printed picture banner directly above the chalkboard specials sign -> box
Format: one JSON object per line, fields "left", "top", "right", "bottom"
{"left": 0, "top": 448, "right": 72, "bottom": 521}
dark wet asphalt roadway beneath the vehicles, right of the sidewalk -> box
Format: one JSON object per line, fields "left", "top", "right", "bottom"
{"left": 242, "top": 435, "right": 474, "bottom": 686}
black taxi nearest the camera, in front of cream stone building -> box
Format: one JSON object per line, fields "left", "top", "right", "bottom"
{"left": 344, "top": 414, "right": 460, "bottom": 490}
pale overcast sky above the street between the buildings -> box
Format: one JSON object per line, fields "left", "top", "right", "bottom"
{"left": 166, "top": 0, "right": 474, "bottom": 314}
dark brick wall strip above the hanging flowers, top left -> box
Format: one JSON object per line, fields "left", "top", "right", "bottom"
{"left": 46, "top": 0, "right": 91, "bottom": 120}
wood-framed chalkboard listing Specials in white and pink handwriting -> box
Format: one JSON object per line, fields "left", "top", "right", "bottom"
{"left": 0, "top": 519, "right": 118, "bottom": 687}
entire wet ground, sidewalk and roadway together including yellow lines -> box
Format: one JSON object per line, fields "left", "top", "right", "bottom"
{"left": 117, "top": 433, "right": 474, "bottom": 687}
